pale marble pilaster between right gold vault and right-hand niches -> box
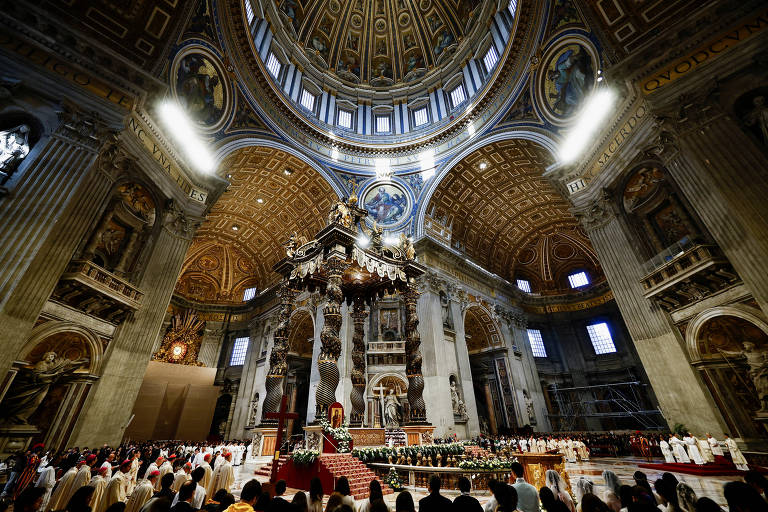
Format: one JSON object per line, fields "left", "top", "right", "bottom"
{"left": 577, "top": 195, "right": 724, "bottom": 436}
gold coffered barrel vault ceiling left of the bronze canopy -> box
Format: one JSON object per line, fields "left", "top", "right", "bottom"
{"left": 177, "top": 146, "right": 337, "bottom": 302}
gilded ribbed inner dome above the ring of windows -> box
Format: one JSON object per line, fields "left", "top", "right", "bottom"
{"left": 275, "top": 0, "right": 480, "bottom": 87}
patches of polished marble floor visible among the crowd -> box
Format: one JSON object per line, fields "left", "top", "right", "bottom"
{"left": 232, "top": 457, "right": 739, "bottom": 510}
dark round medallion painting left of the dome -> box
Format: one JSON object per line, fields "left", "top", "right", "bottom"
{"left": 174, "top": 52, "right": 228, "bottom": 129}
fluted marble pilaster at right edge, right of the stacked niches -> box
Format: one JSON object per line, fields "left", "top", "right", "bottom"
{"left": 658, "top": 98, "right": 768, "bottom": 314}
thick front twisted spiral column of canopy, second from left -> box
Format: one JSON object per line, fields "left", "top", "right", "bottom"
{"left": 315, "top": 256, "right": 347, "bottom": 418}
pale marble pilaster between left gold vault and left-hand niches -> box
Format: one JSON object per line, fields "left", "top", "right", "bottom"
{"left": 69, "top": 201, "right": 194, "bottom": 446}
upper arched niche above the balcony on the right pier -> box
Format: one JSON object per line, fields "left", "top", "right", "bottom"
{"left": 621, "top": 163, "right": 704, "bottom": 258}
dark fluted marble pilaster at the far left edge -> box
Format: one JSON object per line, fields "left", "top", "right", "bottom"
{"left": 0, "top": 116, "right": 118, "bottom": 376}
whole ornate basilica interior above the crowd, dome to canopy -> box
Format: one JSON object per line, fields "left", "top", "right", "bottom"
{"left": 0, "top": 0, "right": 768, "bottom": 460}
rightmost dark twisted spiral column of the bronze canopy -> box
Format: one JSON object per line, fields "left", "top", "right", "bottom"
{"left": 403, "top": 282, "right": 427, "bottom": 423}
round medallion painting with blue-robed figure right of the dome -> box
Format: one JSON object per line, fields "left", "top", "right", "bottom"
{"left": 542, "top": 43, "right": 595, "bottom": 123}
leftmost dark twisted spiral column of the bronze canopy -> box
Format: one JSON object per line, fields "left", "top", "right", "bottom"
{"left": 262, "top": 281, "right": 296, "bottom": 424}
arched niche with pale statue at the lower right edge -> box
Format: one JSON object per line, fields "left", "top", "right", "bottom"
{"left": 693, "top": 315, "right": 768, "bottom": 439}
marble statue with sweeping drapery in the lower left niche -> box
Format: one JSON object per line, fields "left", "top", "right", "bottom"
{"left": 0, "top": 352, "right": 88, "bottom": 425}
